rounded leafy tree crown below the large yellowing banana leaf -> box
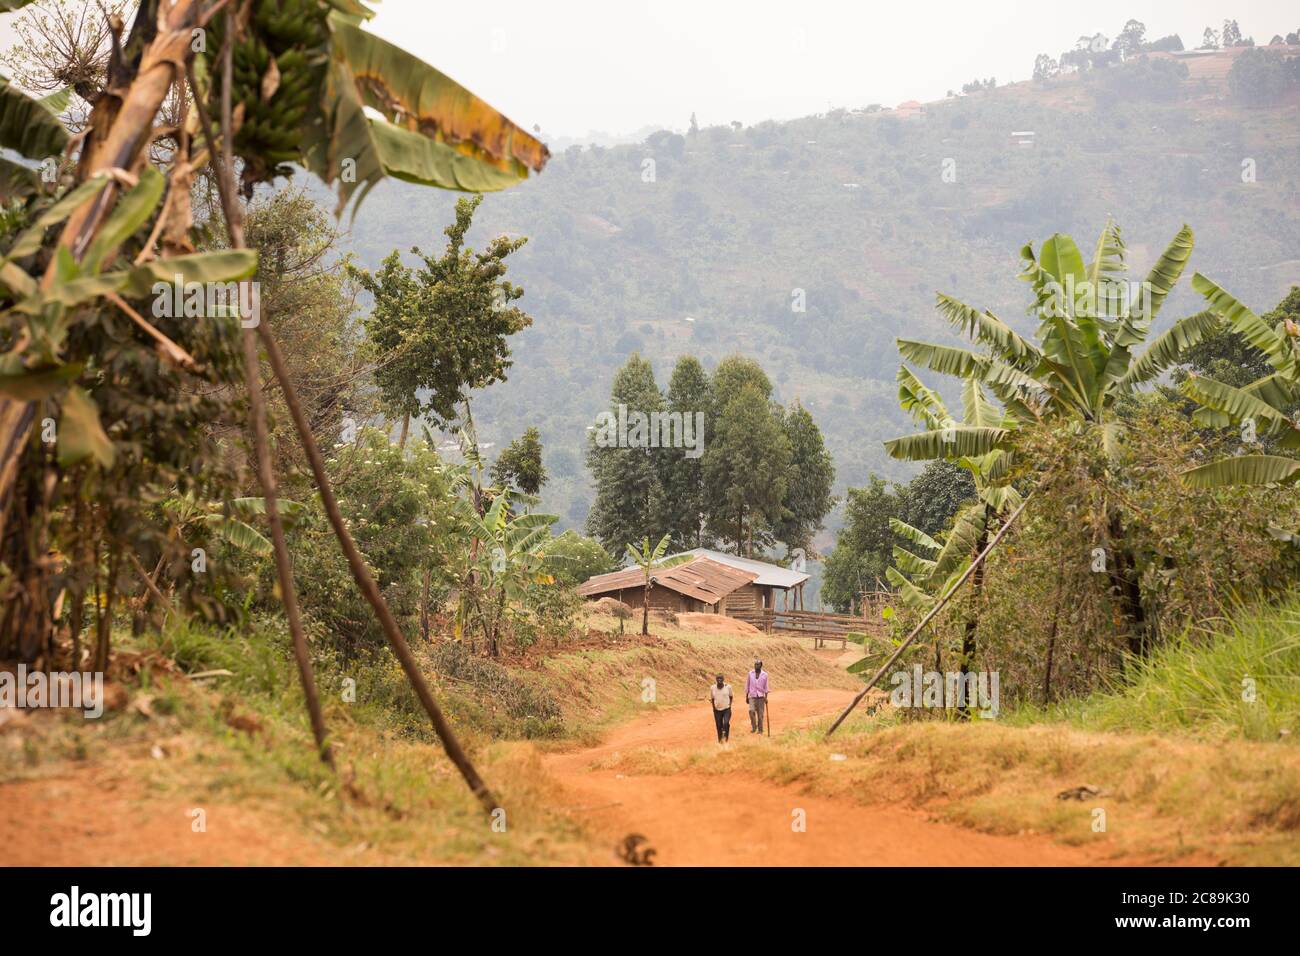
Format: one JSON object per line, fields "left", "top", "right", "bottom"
{"left": 351, "top": 196, "right": 533, "bottom": 444}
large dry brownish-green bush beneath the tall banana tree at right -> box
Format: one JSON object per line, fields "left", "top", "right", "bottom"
{"left": 898, "top": 394, "right": 1300, "bottom": 702}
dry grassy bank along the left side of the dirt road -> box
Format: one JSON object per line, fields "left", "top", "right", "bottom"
{"left": 0, "top": 614, "right": 854, "bottom": 865}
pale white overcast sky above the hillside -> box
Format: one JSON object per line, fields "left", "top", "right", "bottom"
{"left": 0, "top": 0, "right": 1300, "bottom": 137}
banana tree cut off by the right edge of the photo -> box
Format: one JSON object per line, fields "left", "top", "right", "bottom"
{"left": 1180, "top": 272, "right": 1300, "bottom": 488}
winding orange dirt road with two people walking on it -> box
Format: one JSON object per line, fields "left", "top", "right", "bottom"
{"left": 545, "top": 691, "right": 1091, "bottom": 866}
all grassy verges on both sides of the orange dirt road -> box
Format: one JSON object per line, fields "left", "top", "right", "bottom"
{"left": 0, "top": 598, "right": 1300, "bottom": 864}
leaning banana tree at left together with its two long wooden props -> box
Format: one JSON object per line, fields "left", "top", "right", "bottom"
{"left": 0, "top": 0, "right": 547, "bottom": 812}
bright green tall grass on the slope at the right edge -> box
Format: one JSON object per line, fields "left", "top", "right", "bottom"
{"left": 1008, "top": 594, "right": 1300, "bottom": 743}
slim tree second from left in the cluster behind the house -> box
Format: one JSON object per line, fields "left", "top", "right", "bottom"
{"left": 662, "top": 355, "right": 714, "bottom": 550}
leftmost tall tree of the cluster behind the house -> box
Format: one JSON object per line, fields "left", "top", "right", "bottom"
{"left": 586, "top": 354, "right": 664, "bottom": 554}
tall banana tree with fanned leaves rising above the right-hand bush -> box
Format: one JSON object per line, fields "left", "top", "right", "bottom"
{"left": 885, "top": 221, "right": 1221, "bottom": 653}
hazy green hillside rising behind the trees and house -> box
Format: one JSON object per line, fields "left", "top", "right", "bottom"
{"left": 338, "top": 51, "right": 1300, "bottom": 556}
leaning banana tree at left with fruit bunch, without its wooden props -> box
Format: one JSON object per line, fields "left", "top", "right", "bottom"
{"left": 0, "top": 0, "right": 549, "bottom": 598}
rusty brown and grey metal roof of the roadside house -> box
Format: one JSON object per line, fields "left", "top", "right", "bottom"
{"left": 579, "top": 548, "right": 809, "bottom": 617}
